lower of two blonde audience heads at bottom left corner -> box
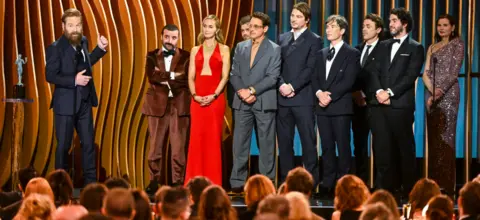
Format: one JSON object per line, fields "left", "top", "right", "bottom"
{"left": 14, "top": 193, "right": 55, "bottom": 220}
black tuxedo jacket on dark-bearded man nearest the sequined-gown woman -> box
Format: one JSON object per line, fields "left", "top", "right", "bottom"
{"left": 368, "top": 37, "right": 425, "bottom": 110}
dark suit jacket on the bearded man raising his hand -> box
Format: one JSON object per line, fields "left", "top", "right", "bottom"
{"left": 45, "top": 35, "right": 106, "bottom": 115}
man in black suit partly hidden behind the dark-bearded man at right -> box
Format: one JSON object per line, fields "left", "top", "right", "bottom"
{"left": 352, "top": 14, "right": 383, "bottom": 183}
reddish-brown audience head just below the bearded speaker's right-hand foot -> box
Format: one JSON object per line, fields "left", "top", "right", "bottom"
{"left": 80, "top": 183, "right": 108, "bottom": 212}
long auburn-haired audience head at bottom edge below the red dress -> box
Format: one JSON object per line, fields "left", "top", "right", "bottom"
{"left": 198, "top": 185, "right": 237, "bottom": 220}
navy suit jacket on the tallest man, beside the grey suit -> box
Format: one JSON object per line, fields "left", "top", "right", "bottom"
{"left": 277, "top": 29, "right": 323, "bottom": 106}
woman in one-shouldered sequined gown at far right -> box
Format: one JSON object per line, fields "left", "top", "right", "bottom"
{"left": 422, "top": 15, "right": 464, "bottom": 197}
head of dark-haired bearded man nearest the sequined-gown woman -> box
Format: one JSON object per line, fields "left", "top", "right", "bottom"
{"left": 389, "top": 8, "right": 413, "bottom": 37}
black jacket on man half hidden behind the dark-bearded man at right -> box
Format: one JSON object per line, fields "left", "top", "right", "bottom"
{"left": 354, "top": 41, "right": 384, "bottom": 104}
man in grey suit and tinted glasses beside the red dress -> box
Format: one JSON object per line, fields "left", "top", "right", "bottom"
{"left": 230, "top": 12, "right": 281, "bottom": 192}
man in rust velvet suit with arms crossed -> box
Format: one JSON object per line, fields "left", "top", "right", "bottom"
{"left": 143, "top": 25, "right": 191, "bottom": 193}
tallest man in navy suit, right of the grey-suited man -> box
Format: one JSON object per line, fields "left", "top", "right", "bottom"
{"left": 277, "top": 2, "right": 323, "bottom": 186}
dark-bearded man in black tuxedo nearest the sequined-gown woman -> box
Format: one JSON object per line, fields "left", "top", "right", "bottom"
{"left": 370, "top": 8, "right": 424, "bottom": 196}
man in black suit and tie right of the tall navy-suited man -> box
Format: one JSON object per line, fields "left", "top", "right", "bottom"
{"left": 312, "top": 15, "right": 360, "bottom": 196}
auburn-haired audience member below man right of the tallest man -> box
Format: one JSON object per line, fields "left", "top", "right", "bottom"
{"left": 332, "top": 175, "right": 370, "bottom": 220}
